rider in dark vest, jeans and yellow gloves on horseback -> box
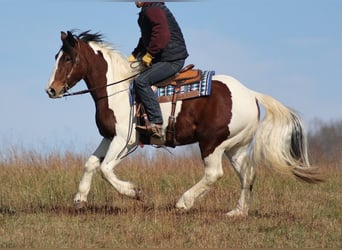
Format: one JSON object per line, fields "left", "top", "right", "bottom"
{"left": 128, "top": 2, "right": 188, "bottom": 138}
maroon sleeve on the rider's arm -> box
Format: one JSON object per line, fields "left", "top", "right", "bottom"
{"left": 146, "top": 7, "right": 171, "bottom": 55}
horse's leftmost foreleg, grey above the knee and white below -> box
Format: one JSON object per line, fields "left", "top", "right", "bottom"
{"left": 74, "top": 139, "right": 110, "bottom": 208}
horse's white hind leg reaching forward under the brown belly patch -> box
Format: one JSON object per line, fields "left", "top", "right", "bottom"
{"left": 176, "top": 149, "right": 223, "bottom": 210}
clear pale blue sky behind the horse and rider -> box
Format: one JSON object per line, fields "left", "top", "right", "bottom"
{"left": 0, "top": 0, "right": 342, "bottom": 152}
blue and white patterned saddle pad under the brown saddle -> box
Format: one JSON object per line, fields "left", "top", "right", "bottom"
{"left": 155, "top": 70, "right": 215, "bottom": 102}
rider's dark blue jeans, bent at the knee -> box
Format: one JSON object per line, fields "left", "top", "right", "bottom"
{"left": 134, "top": 60, "right": 185, "bottom": 124}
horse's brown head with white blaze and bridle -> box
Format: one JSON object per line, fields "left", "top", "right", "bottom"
{"left": 46, "top": 31, "right": 86, "bottom": 98}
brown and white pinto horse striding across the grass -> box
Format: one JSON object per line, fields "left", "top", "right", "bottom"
{"left": 46, "top": 31, "right": 320, "bottom": 216}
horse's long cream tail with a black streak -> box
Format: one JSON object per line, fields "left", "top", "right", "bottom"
{"left": 250, "top": 92, "right": 323, "bottom": 183}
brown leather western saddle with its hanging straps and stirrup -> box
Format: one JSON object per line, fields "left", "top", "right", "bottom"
{"left": 136, "top": 64, "right": 202, "bottom": 147}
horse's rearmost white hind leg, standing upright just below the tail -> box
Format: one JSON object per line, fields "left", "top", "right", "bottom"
{"left": 225, "top": 146, "right": 255, "bottom": 216}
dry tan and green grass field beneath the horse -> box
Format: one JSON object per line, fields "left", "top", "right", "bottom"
{"left": 0, "top": 146, "right": 342, "bottom": 248}
